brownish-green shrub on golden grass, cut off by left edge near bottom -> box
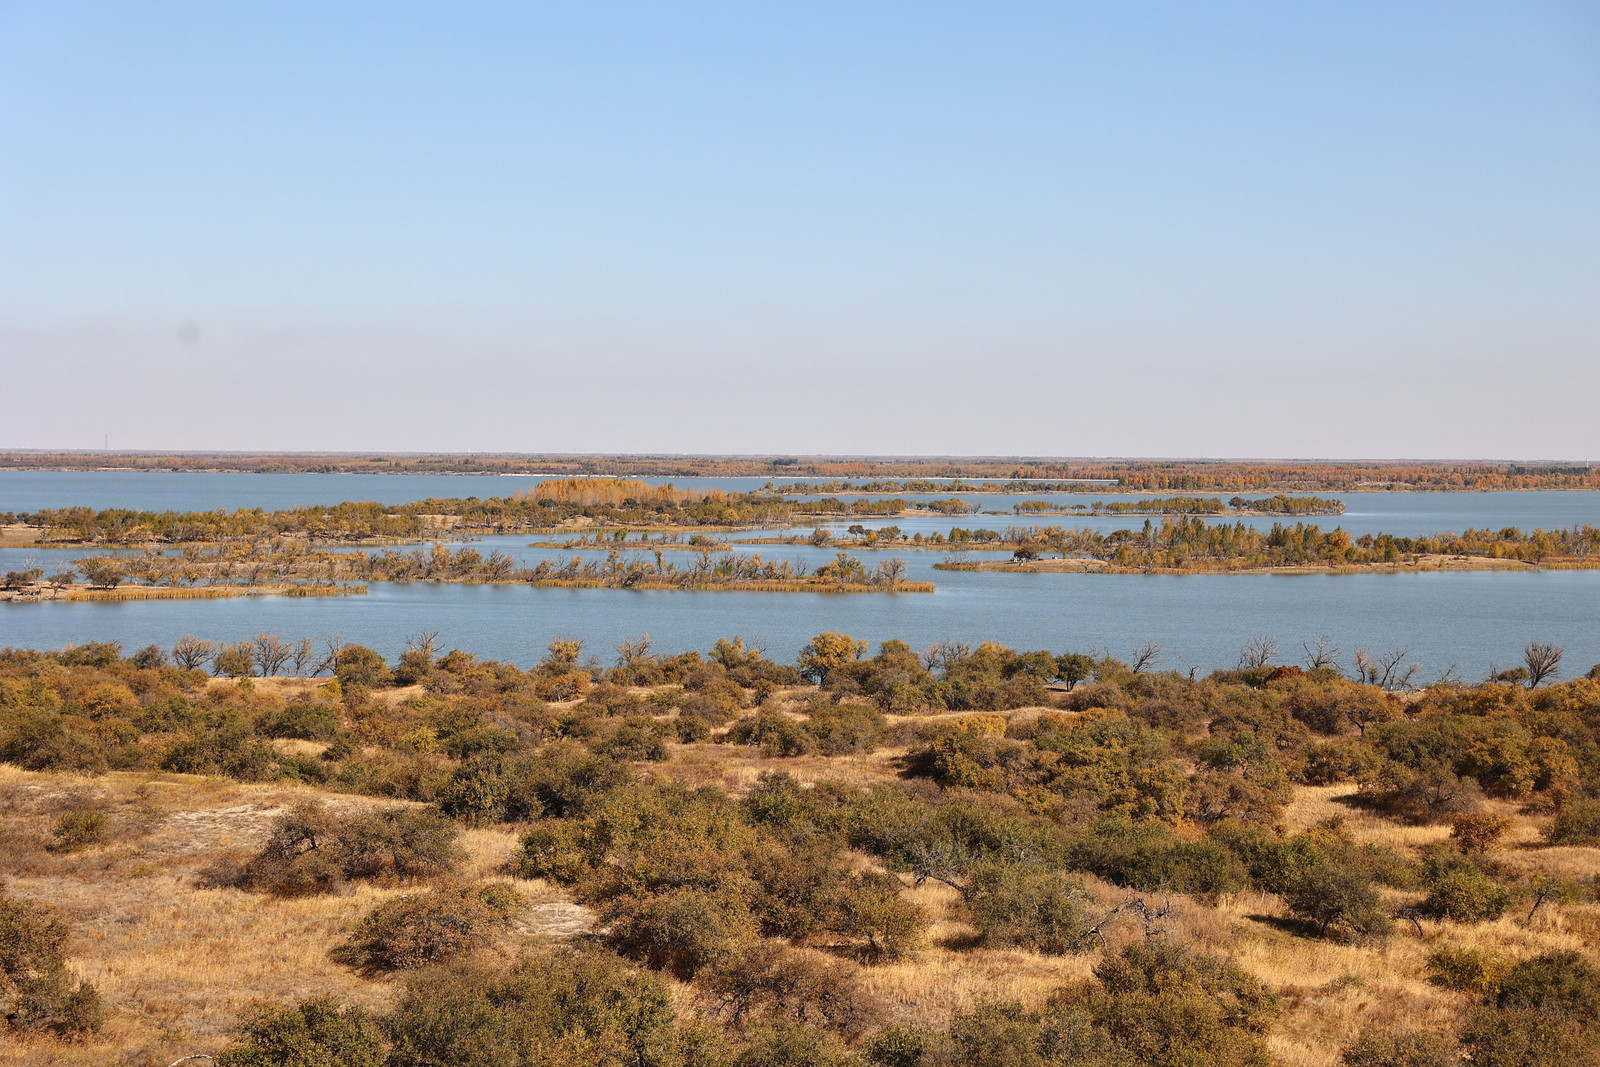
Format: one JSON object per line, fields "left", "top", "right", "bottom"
{"left": 0, "top": 883, "right": 104, "bottom": 1037}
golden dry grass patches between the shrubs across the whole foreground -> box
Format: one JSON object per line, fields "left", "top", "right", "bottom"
{"left": 0, "top": 758, "right": 1600, "bottom": 1067}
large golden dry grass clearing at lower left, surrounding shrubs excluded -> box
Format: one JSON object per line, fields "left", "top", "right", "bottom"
{"left": 0, "top": 768, "right": 406, "bottom": 1065}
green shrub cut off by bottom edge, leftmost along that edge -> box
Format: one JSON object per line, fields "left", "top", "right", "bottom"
{"left": 216, "top": 997, "right": 387, "bottom": 1067}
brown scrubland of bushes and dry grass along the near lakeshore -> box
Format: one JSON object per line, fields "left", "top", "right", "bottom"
{"left": 0, "top": 633, "right": 1600, "bottom": 1067}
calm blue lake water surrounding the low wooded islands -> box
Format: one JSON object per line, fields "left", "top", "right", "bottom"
{"left": 0, "top": 472, "right": 1600, "bottom": 680}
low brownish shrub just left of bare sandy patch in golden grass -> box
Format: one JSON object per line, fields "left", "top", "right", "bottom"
{"left": 334, "top": 883, "right": 520, "bottom": 976}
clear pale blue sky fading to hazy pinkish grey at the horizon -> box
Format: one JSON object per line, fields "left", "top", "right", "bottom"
{"left": 0, "top": 0, "right": 1600, "bottom": 461}
